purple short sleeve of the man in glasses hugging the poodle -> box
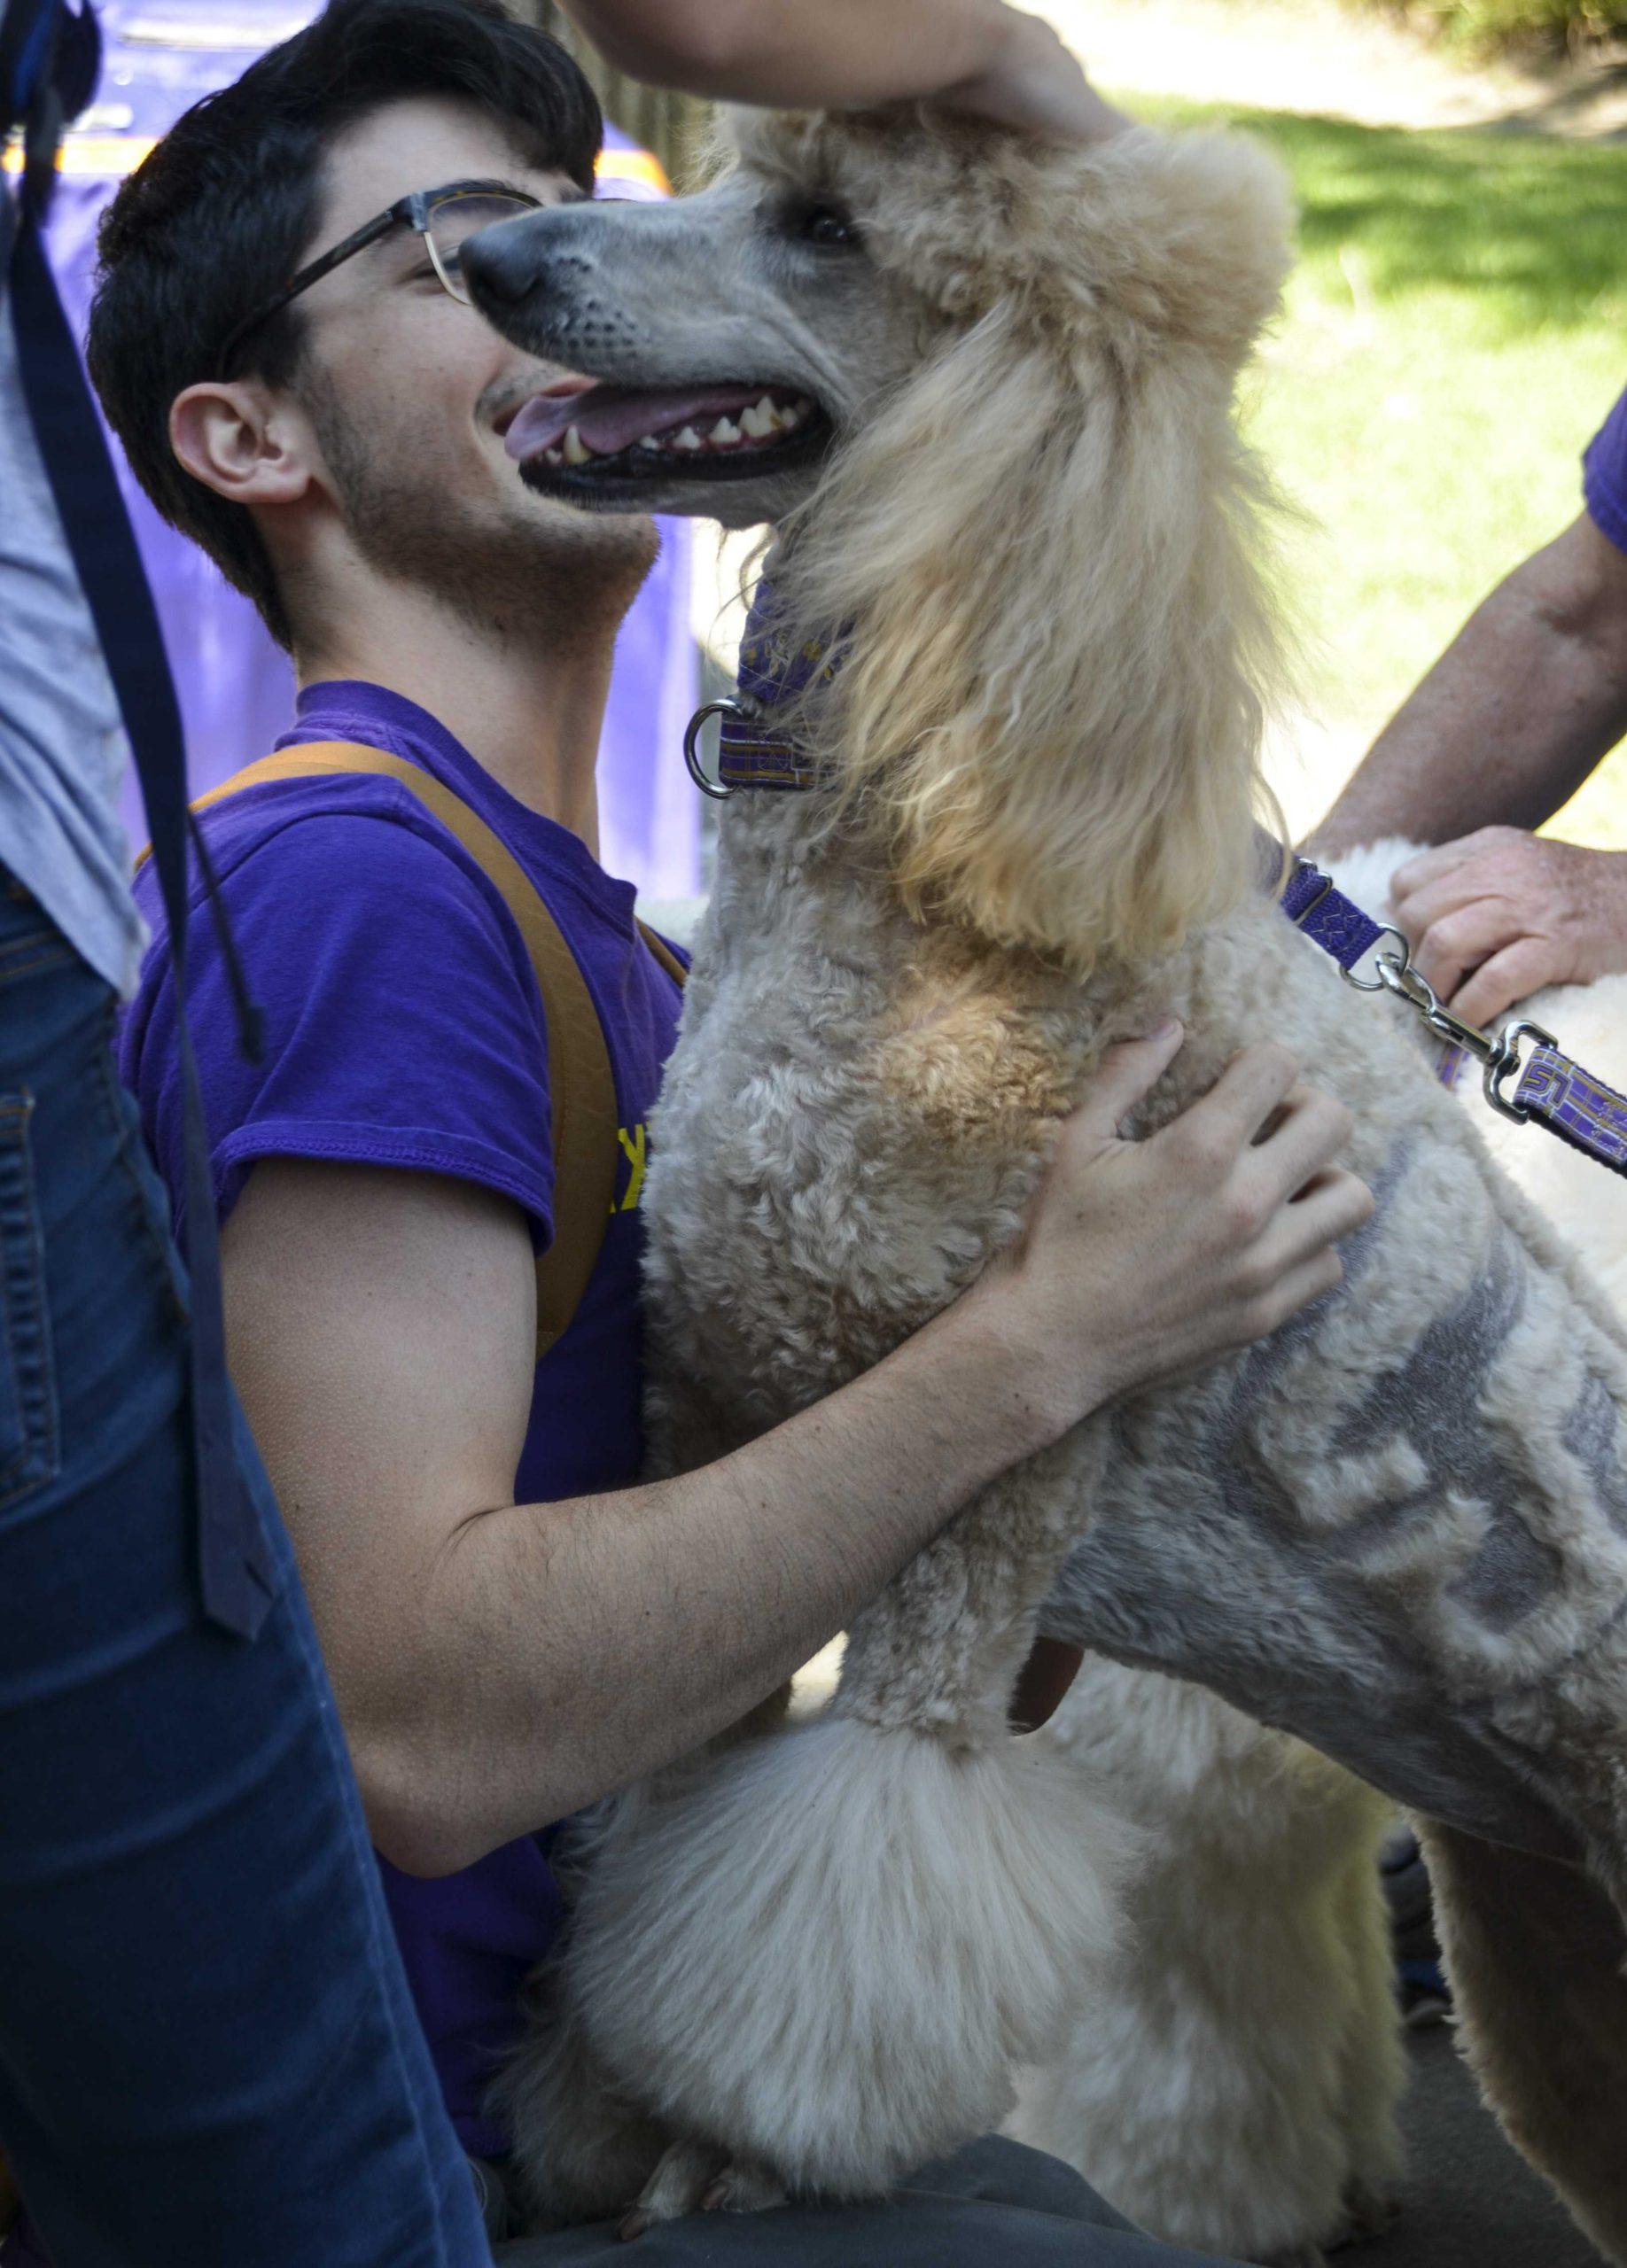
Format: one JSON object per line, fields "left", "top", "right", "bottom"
{"left": 121, "top": 812, "right": 554, "bottom": 1247}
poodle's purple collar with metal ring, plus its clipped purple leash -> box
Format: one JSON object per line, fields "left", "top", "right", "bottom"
{"left": 683, "top": 579, "right": 1627, "bottom": 1175}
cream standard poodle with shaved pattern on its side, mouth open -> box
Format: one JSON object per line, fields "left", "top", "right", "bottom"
{"left": 467, "top": 102, "right": 1627, "bottom": 2261}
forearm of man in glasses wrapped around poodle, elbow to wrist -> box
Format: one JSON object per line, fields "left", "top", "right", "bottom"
{"left": 365, "top": 1300, "right": 1066, "bottom": 1874}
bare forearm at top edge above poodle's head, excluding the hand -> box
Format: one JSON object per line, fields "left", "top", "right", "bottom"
{"left": 565, "top": 0, "right": 1012, "bottom": 109}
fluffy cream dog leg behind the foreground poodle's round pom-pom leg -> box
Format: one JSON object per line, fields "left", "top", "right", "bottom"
{"left": 1012, "top": 1658, "right": 1396, "bottom": 2264}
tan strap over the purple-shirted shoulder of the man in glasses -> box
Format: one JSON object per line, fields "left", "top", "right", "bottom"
{"left": 136, "top": 740, "right": 683, "bottom": 1361}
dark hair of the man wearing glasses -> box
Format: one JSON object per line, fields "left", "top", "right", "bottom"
{"left": 89, "top": 0, "right": 603, "bottom": 647}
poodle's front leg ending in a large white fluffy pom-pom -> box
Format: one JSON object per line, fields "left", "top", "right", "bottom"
{"left": 557, "top": 1445, "right": 1125, "bottom": 2198}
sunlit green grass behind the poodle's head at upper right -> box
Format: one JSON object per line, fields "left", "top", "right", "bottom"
{"left": 1130, "top": 97, "right": 1627, "bottom": 846}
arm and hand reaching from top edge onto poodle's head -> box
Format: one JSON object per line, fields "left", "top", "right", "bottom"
{"left": 551, "top": 0, "right": 1125, "bottom": 141}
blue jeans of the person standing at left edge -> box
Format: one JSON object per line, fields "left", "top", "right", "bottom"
{"left": 0, "top": 868, "right": 490, "bottom": 2268}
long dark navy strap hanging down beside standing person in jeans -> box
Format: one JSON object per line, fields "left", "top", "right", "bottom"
{"left": 7, "top": 18, "right": 276, "bottom": 1637}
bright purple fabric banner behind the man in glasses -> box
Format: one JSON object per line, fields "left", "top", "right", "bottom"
{"left": 48, "top": 0, "right": 701, "bottom": 898}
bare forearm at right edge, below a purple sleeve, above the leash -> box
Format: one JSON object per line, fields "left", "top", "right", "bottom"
{"left": 1310, "top": 522, "right": 1627, "bottom": 855}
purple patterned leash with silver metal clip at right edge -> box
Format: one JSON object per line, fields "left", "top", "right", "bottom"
{"left": 1282, "top": 859, "right": 1627, "bottom": 1175}
